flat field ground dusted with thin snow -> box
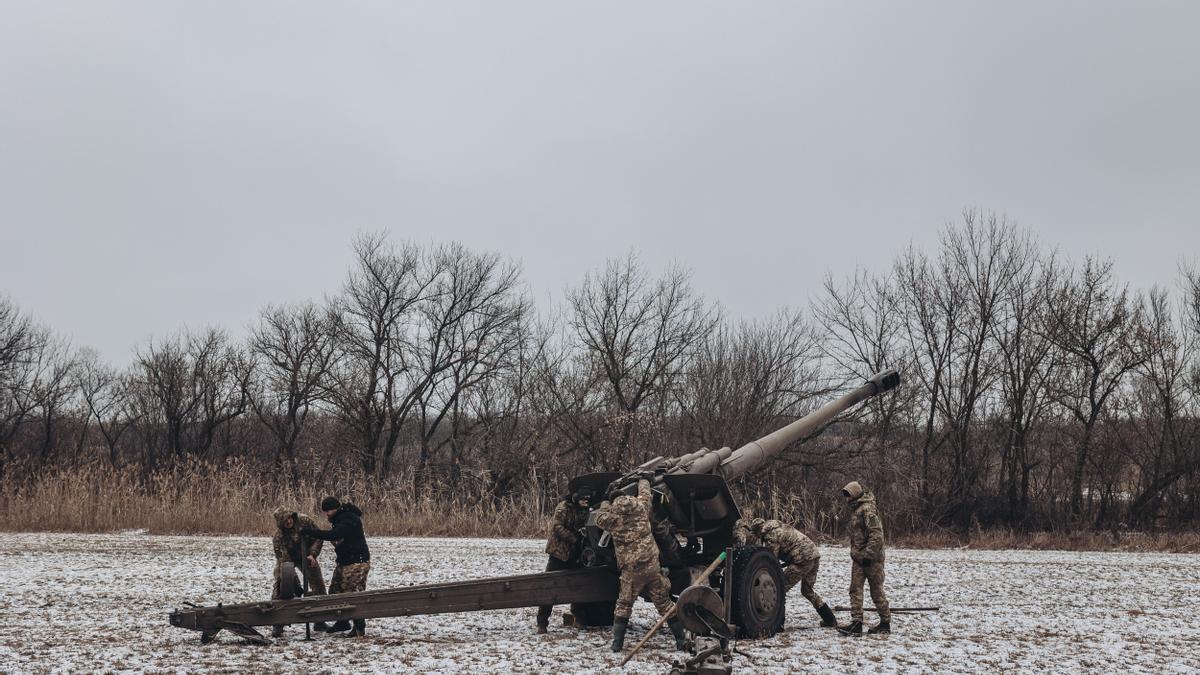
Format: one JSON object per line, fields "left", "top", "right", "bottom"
{"left": 0, "top": 533, "right": 1200, "bottom": 673}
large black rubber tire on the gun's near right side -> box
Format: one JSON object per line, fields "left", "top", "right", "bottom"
{"left": 732, "top": 546, "right": 786, "bottom": 640}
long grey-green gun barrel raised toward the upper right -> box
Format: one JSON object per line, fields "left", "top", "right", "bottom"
{"left": 710, "top": 369, "right": 900, "bottom": 480}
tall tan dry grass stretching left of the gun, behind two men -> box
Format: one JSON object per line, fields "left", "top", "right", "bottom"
{"left": 0, "top": 462, "right": 545, "bottom": 537}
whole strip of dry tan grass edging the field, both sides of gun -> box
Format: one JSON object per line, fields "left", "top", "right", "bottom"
{"left": 0, "top": 462, "right": 1200, "bottom": 552}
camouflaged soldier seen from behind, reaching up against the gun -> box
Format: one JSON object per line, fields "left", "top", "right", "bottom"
{"left": 596, "top": 477, "right": 684, "bottom": 652}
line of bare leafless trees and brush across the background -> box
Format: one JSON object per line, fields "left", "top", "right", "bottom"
{"left": 0, "top": 210, "right": 1200, "bottom": 530}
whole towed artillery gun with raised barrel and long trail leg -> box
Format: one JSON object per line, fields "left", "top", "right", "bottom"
{"left": 169, "top": 370, "right": 900, "bottom": 643}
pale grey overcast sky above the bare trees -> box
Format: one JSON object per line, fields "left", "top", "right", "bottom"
{"left": 0, "top": 0, "right": 1200, "bottom": 363}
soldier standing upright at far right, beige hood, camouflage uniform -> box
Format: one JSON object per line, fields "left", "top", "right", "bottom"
{"left": 839, "top": 480, "right": 892, "bottom": 635}
